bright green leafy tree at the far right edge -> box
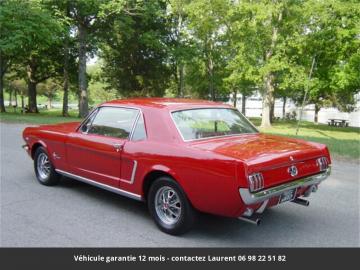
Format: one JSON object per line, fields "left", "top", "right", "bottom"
{"left": 296, "top": 0, "right": 360, "bottom": 123}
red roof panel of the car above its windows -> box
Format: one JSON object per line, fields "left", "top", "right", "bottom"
{"left": 101, "top": 98, "right": 231, "bottom": 110}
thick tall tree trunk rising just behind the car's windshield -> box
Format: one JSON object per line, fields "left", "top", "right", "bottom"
{"left": 79, "top": 23, "right": 89, "bottom": 117}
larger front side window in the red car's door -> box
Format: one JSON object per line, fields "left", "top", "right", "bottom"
{"left": 88, "top": 107, "right": 139, "bottom": 139}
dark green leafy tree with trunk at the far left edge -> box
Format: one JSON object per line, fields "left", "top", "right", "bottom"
{"left": 0, "top": 0, "right": 61, "bottom": 112}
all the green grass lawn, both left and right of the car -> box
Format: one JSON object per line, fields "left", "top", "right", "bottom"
{"left": 0, "top": 108, "right": 360, "bottom": 160}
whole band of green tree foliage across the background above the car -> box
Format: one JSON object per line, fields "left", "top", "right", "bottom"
{"left": 0, "top": 0, "right": 360, "bottom": 127}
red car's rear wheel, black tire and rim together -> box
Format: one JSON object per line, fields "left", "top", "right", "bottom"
{"left": 147, "top": 177, "right": 196, "bottom": 235}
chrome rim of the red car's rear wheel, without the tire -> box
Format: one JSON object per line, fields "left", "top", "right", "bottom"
{"left": 155, "top": 186, "right": 181, "bottom": 225}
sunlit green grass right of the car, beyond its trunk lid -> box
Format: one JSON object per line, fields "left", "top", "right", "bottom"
{"left": 250, "top": 118, "right": 360, "bottom": 160}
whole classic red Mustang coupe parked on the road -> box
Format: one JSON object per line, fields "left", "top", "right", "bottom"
{"left": 23, "top": 98, "right": 331, "bottom": 235}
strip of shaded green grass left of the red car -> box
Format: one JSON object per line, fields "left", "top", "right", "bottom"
{"left": 0, "top": 108, "right": 81, "bottom": 124}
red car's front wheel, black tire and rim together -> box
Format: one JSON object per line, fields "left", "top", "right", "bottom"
{"left": 34, "top": 146, "right": 61, "bottom": 186}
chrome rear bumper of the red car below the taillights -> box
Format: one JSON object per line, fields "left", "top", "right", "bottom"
{"left": 239, "top": 167, "right": 331, "bottom": 205}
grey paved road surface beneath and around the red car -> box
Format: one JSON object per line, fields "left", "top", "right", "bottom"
{"left": 0, "top": 123, "right": 360, "bottom": 247}
